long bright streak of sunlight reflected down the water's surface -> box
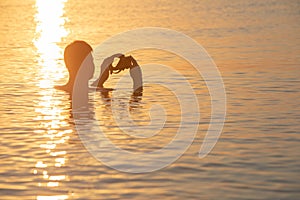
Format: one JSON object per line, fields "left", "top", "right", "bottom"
{"left": 33, "top": 0, "right": 72, "bottom": 199}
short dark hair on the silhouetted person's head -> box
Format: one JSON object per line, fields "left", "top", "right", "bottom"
{"left": 64, "top": 40, "right": 93, "bottom": 75}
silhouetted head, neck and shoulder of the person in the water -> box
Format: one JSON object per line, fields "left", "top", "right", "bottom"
{"left": 55, "top": 40, "right": 95, "bottom": 94}
